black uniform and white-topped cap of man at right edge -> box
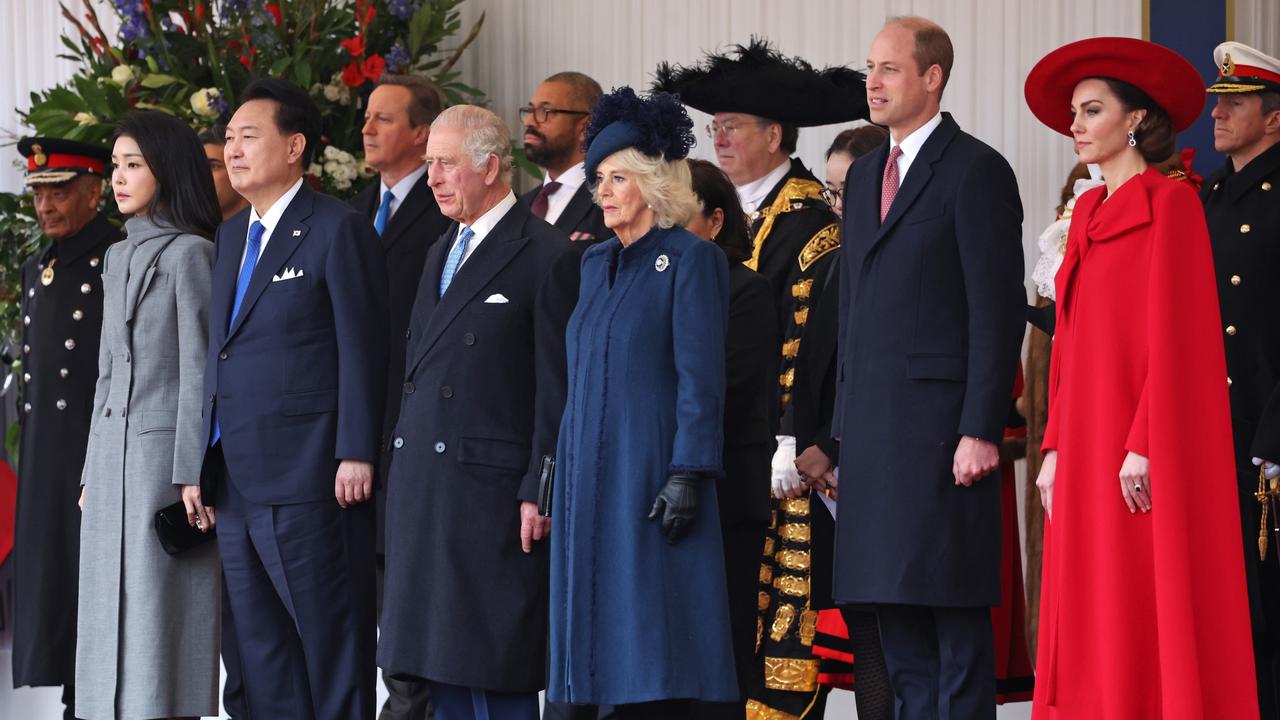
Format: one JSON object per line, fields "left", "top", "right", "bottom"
{"left": 1201, "top": 42, "right": 1280, "bottom": 717}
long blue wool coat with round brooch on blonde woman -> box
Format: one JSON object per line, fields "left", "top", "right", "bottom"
{"left": 548, "top": 228, "right": 737, "bottom": 705}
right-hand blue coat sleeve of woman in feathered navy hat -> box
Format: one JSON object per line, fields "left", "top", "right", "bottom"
{"left": 668, "top": 242, "right": 728, "bottom": 475}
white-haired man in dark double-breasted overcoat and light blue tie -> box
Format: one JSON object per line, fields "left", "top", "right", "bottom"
{"left": 378, "top": 105, "right": 577, "bottom": 720}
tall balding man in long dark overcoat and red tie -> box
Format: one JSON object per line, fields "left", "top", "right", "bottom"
{"left": 832, "top": 17, "right": 1027, "bottom": 720}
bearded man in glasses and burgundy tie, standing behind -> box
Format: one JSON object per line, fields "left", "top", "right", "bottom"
{"left": 520, "top": 72, "right": 613, "bottom": 243}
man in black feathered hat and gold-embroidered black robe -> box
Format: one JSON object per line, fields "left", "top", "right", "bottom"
{"left": 653, "top": 40, "right": 867, "bottom": 717}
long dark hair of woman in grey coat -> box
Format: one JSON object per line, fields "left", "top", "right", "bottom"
{"left": 113, "top": 110, "right": 223, "bottom": 240}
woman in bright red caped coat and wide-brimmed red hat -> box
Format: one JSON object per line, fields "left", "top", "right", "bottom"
{"left": 1025, "top": 37, "right": 1258, "bottom": 720}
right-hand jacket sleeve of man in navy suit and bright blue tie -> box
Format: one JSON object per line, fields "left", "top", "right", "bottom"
{"left": 325, "top": 213, "right": 388, "bottom": 462}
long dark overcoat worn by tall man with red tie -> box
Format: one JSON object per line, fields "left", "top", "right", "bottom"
{"left": 832, "top": 114, "right": 1027, "bottom": 607}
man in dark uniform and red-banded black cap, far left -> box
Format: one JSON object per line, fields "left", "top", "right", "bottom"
{"left": 13, "top": 137, "right": 120, "bottom": 717}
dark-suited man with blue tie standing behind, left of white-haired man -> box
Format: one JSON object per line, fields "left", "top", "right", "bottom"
{"left": 351, "top": 76, "right": 449, "bottom": 720}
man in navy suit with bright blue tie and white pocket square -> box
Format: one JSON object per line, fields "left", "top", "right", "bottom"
{"left": 201, "top": 79, "right": 387, "bottom": 720}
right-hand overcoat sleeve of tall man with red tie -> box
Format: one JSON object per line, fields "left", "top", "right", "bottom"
{"left": 955, "top": 146, "right": 1027, "bottom": 443}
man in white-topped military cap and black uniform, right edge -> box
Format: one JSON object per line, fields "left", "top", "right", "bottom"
{"left": 1201, "top": 42, "right": 1280, "bottom": 717}
